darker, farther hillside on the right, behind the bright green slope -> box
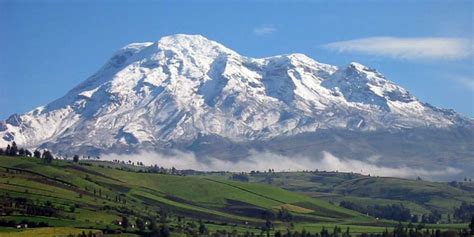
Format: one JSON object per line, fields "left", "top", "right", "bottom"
{"left": 231, "top": 172, "right": 474, "bottom": 218}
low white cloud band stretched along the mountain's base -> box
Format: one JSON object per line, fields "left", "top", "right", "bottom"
{"left": 102, "top": 150, "right": 461, "bottom": 179}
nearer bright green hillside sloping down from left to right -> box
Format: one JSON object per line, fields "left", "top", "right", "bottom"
{"left": 0, "top": 157, "right": 373, "bottom": 235}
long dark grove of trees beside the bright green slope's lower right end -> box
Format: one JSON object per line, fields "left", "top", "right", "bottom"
{"left": 340, "top": 201, "right": 412, "bottom": 221}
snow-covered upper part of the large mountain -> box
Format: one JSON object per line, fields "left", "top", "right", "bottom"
{"left": 0, "top": 35, "right": 473, "bottom": 156}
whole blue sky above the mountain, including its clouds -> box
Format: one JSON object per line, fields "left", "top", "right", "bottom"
{"left": 0, "top": 0, "right": 474, "bottom": 119}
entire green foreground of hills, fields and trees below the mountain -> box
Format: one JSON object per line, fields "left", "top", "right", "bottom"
{"left": 0, "top": 144, "right": 474, "bottom": 237}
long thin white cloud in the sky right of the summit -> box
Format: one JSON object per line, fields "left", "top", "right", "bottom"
{"left": 323, "top": 37, "right": 473, "bottom": 60}
